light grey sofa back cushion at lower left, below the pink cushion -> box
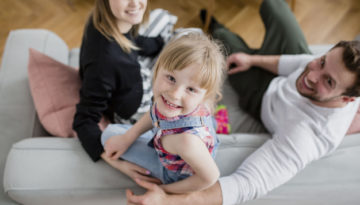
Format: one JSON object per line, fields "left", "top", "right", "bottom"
{"left": 4, "top": 137, "right": 141, "bottom": 205}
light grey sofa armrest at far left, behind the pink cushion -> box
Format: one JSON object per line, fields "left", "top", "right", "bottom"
{"left": 0, "top": 29, "right": 69, "bottom": 204}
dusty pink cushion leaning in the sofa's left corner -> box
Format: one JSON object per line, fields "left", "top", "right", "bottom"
{"left": 28, "top": 48, "right": 107, "bottom": 137}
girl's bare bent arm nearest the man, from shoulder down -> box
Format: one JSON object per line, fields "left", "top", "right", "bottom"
{"left": 161, "top": 133, "right": 220, "bottom": 193}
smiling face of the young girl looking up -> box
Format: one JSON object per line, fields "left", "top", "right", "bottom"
{"left": 153, "top": 64, "right": 207, "bottom": 118}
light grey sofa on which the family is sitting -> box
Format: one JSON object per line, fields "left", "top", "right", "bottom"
{"left": 0, "top": 29, "right": 360, "bottom": 205}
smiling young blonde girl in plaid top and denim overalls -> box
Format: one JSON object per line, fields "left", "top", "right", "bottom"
{"left": 102, "top": 33, "right": 224, "bottom": 193}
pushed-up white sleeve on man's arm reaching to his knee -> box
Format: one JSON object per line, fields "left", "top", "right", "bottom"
{"left": 278, "top": 54, "right": 314, "bottom": 76}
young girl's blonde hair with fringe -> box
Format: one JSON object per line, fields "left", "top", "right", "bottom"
{"left": 153, "top": 32, "right": 225, "bottom": 108}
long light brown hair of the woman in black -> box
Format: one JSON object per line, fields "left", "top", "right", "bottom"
{"left": 93, "top": 0, "right": 150, "bottom": 53}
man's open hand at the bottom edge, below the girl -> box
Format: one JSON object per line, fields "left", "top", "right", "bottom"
{"left": 126, "top": 179, "right": 169, "bottom": 205}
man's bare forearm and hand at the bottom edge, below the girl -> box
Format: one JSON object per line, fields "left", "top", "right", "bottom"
{"left": 126, "top": 179, "right": 222, "bottom": 205}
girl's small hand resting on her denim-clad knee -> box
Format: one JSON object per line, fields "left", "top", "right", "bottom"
{"left": 104, "top": 133, "right": 134, "bottom": 160}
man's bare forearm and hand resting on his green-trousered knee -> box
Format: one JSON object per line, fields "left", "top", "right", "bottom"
{"left": 226, "top": 53, "right": 280, "bottom": 74}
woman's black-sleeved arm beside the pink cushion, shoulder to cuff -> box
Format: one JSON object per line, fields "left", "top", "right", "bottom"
{"left": 73, "top": 20, "right": 116, "bottom": 161}
